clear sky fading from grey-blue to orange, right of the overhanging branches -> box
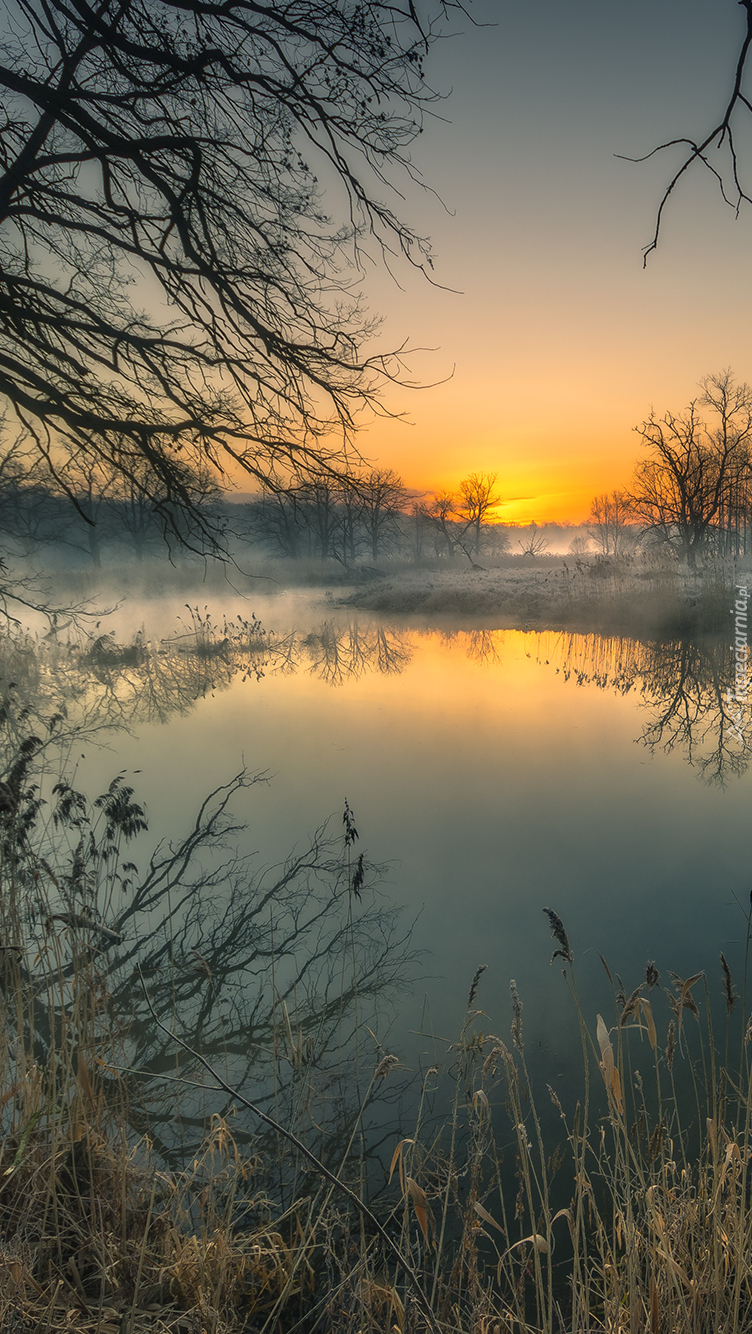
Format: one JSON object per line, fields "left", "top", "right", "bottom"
{"left": 341, "top": 0, "right": 752, "bottom": 523}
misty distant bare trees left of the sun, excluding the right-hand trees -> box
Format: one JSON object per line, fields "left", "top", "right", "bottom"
{"left": 0, "top": 448, "right": 547, "bottom": 570}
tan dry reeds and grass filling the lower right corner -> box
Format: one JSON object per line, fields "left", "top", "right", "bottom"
{"left": 370, "top": 928, "right": 752, "bottom": 1334}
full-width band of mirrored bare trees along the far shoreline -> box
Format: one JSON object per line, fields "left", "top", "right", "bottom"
{"left": 0, "top": 607, "right": 752, "bottom": 786}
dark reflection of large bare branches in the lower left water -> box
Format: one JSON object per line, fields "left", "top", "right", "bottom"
{"left": 0, "top": 739, "right": 411, "bottom": 1185}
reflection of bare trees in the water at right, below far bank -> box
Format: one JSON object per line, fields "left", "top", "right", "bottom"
{"left": 537, "top": 635, "right": 752, "bottom": 786}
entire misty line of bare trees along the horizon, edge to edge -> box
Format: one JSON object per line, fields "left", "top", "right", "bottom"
{"left": 11, "top": 371, "right": 752, "bottom": 571}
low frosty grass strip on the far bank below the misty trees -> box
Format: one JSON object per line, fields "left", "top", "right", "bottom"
{"left": 17, "top": 552, "right": 752, "bottom": 638}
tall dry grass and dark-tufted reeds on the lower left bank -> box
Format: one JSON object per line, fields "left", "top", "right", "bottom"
{"left": 0, "top": 814, "right": 289, "bottom": 1334}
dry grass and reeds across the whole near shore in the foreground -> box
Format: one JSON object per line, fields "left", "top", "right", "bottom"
{"left": 0, "top": 720, "right": 752, "bottom": 1334}
